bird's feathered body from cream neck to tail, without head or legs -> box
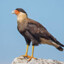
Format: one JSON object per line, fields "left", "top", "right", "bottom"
{"left": 17, "top": 12, "right": 62, "bottom": 48}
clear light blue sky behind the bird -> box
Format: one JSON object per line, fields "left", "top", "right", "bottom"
{"left": 0, "top": 0, "right": 64, "bottom": 64}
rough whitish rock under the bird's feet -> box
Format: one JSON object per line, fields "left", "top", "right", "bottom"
{"left": 12, "top": 56, "right": 64, "bottom": 64}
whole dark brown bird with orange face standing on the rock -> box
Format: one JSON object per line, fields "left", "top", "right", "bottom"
{"left": 12, "top": 8, "right": 64, "bottom": 61}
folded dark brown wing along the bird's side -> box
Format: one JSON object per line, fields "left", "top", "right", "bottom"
{"left": 26, "top": 20, "right": 64, "bottom": 47}
